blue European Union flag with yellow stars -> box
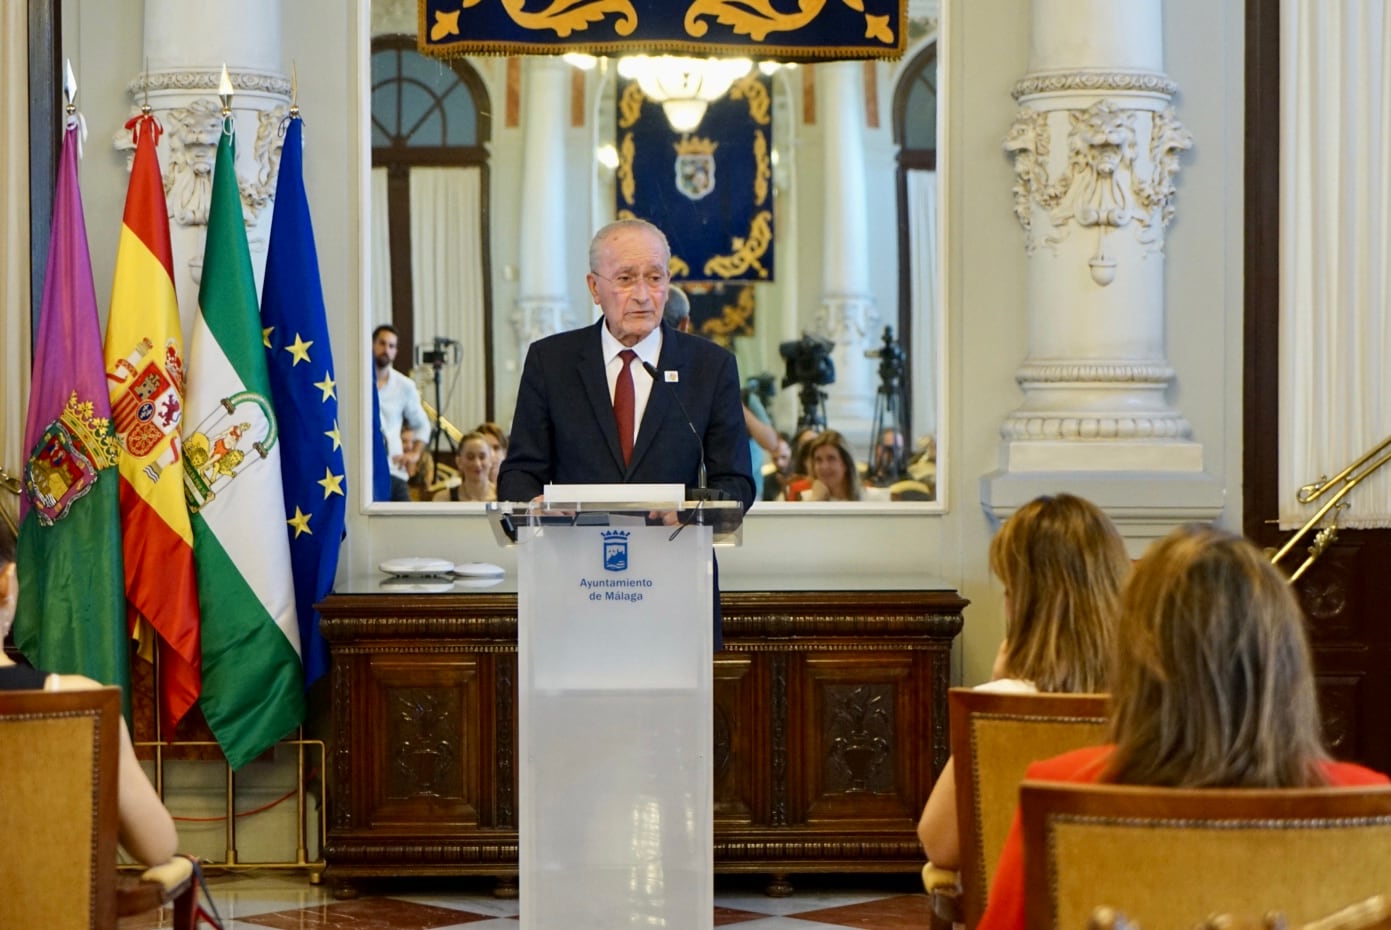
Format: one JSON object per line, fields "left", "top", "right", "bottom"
{"left": 262, "top": 115, "right": 348, "bottom": 687}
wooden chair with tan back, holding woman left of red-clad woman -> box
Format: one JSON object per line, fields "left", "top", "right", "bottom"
{"left": 924, "top": 688, "right": 1107, "bottom": 930}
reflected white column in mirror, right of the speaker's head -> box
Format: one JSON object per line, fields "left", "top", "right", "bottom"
{"left": 810, "top": 61, "right": 882, "bottom": 448}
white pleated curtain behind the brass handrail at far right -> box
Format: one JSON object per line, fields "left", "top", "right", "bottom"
{"left": 1280, "top": 0, "right": 1391, "bottom": 528}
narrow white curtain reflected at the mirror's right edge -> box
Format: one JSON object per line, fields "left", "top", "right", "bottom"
{"left": 904, "top": 171, "right": 946, "bottom": 449}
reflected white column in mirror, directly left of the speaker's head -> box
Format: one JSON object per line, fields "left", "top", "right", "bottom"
{"left": 512, "top": 56, "right": 570, "bottom": 359}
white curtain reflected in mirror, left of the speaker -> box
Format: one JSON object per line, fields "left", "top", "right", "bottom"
{"left": 410, "top": 168, "right": 487, "bottom": 432}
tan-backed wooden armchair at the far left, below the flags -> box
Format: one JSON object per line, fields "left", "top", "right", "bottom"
{"left": 0, "top": 688, "right": 195, "bottom": 930}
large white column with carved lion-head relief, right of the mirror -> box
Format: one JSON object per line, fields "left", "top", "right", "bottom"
{"left": 982, "top": 0, "right": 1221, "bottom": 537}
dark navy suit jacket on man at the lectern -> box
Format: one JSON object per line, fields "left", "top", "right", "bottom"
{"left": 498, "top": 320, "right": 754, "bottom": 649}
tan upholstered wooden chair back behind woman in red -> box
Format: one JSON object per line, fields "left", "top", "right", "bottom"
{"left": 1020, "top": 781, "right": 1391, "bottom": 930}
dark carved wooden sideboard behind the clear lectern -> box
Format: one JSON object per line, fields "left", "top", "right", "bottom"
{"left": 320, "top": 580, "right": 968, "bottom": 897}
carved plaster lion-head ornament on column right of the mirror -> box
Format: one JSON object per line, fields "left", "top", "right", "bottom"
{"left": 1004, "top": 99, "right": 1193, "bottom": 286}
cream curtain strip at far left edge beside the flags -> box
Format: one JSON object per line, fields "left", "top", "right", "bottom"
{"left": 0, "top": 3, "right": 31, "bottom": 489}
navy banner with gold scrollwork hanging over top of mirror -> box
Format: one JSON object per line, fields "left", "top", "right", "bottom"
{"left": 419, "top": 0, "right": 908, "bottom": 61}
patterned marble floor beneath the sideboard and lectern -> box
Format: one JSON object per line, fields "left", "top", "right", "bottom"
{"left": 120, "top": 870, "right": 928, "bottom": 930}
